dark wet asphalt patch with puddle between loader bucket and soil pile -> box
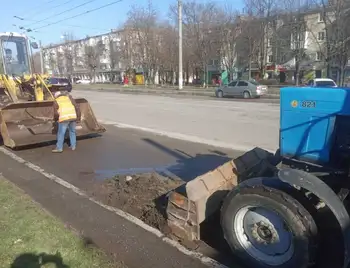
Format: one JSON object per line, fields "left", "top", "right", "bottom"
{"left": 16, "top": 126, "right": 242, "bottom": 187}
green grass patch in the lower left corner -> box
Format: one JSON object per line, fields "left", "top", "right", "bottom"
{"left": 0, "top": 176, "right": 126, "bottom": 268}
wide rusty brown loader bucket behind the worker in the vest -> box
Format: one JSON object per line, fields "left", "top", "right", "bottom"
{"left": 0, "top": 98, "right": 106, "bottom": 148}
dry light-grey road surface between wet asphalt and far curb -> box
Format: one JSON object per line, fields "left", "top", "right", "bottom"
{"left": 73, "top": 90, "right": 279, "bottom": 151}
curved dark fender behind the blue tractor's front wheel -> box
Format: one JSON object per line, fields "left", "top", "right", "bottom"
{"left": 278, "top": 168, "right": 350, "bottom": 268}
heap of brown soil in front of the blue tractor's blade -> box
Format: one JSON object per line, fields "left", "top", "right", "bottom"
{"left": 92, "top": 173, "right": 182, "bottom": 232}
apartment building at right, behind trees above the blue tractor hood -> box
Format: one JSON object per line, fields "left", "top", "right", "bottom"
{"left": 264, "top": 5, "right": 350, "bottom": 80}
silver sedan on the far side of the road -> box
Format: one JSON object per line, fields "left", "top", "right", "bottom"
{"left": 215, "top": 80, "right": 268, "bottom": 99}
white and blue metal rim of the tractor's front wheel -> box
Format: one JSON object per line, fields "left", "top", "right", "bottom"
{"left": 234, "top": 206, "right": 294, "bottom": 266}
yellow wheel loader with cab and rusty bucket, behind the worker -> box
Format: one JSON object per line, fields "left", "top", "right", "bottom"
{"left": 0, "top": 32, "right": 106, "bottom": 148}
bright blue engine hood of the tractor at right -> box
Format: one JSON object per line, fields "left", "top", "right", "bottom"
{"left": 280, "top": 87, "right": 350, "bottom": 169}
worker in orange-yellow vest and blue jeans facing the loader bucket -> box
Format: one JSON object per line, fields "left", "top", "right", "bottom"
{"left": 52, "top": 91, "right": 81, "bottom": 153}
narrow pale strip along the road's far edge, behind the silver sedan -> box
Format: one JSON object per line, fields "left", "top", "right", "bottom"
{"left": 73, "top": 84, "right": 279, "bottom": 99}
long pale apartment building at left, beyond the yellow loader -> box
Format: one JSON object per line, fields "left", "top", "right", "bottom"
{"left": 43, "top": 31, "right": 124, "bottom": 82}
